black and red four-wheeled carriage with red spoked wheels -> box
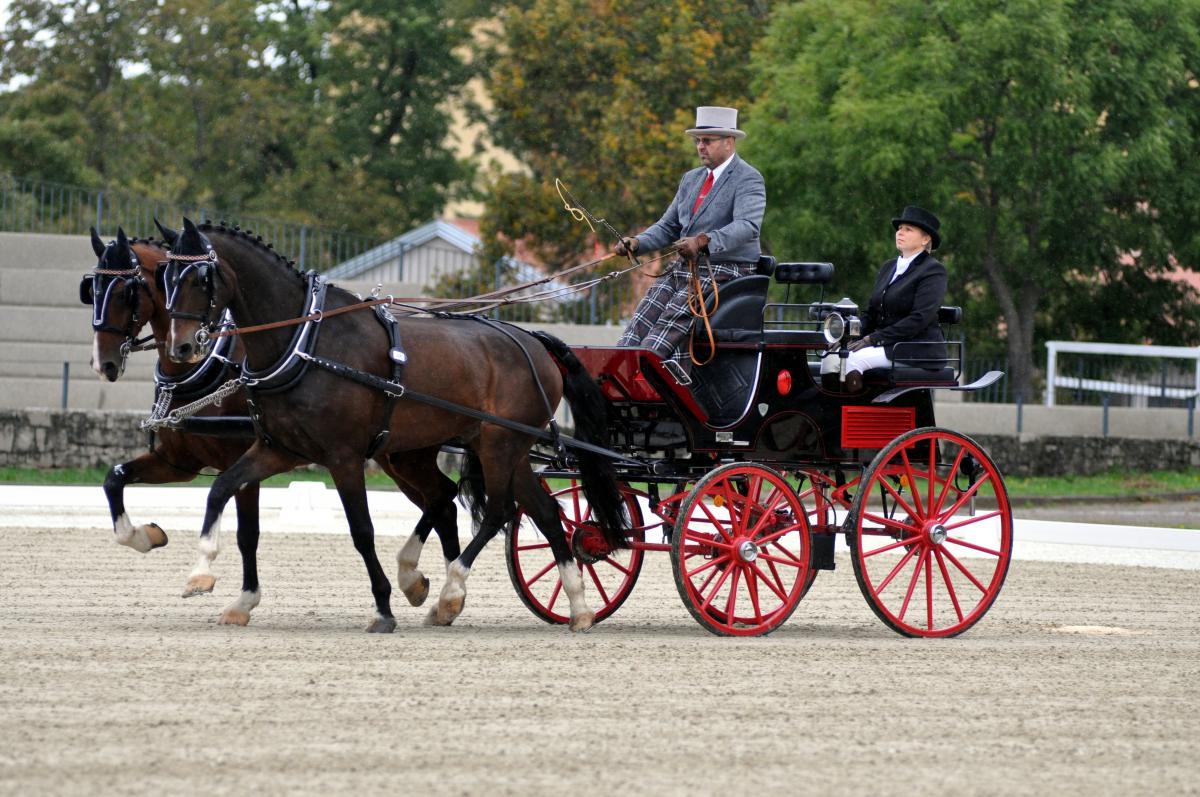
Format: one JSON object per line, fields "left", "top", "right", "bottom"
{"left": 505, "top": 257, "right": 1013, "bottom": 636}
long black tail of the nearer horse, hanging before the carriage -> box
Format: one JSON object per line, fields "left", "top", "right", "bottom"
{"left": 532, "top": 332, "right": 631, "bottom": 549}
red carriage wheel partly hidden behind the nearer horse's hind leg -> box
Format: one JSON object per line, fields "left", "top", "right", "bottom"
{"left": 504, "top": 480, "right": 643, "bottom": 624}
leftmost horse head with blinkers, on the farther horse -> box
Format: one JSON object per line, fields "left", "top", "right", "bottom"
{"left": 79, "top": 228, "right": 154, "bottom": 382}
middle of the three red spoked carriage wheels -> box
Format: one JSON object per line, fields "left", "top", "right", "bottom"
{"left": 671, "top": 463, "right": 810, "bottom": 636}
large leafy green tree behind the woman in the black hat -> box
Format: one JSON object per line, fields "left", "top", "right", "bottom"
{"left": 748, "top": 0, "right": 1200, "bottom": 399}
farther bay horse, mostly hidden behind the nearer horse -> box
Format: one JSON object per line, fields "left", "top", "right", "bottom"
{"left": 79, "top": 226, "right": 461, "bottom": 625}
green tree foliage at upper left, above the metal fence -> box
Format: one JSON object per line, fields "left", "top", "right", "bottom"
{"left": 0, "top": 0, "right": 487, "bottom": 234}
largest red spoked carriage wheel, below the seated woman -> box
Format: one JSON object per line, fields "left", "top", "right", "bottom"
{"left": 847, "top": 427, "right": 1013, "bottom": 636}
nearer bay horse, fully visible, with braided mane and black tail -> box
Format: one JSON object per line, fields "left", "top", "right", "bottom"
{"left": 160, "top": 218, "right": 629, "bottom": 633}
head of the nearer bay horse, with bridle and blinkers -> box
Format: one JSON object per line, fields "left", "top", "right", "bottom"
{"left": 164, "top": 218, "right": 235, "bottom": 362}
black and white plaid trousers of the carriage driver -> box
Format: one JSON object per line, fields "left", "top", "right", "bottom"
{"left": 617, "top": 259, "right": 757, "bottom": 373}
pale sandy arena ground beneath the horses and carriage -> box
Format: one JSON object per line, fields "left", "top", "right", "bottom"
{"left": 0, "top": 528, "right": 1200, "bottom": 797}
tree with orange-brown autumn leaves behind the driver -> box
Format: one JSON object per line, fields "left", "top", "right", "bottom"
{"left": 481, "top": 0, "right": 766, "bottom": 271}
